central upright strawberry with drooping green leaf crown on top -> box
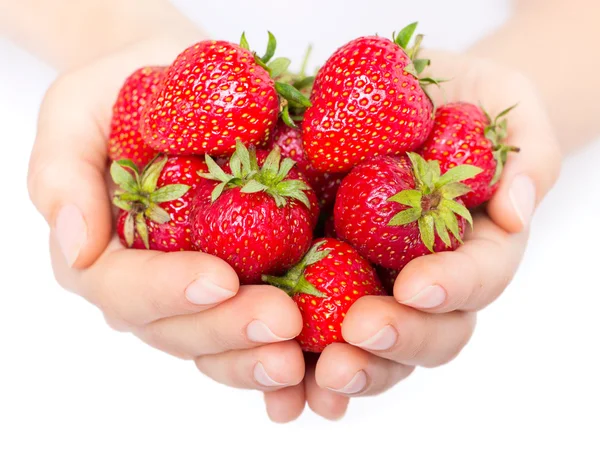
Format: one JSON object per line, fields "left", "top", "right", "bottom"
{"left": 191, "top": 141, "right": 319, "bottom": 284}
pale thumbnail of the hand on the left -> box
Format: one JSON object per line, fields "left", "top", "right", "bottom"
{"left": 54, "top": 205, "right": 87, "bottom": 267}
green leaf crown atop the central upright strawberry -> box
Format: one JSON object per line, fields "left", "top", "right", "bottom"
{"left": 199, "top": 140, "right": 310, "bottom": 209}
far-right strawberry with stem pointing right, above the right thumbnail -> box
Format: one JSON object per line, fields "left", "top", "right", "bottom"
{"left": 421, "top": 103, "right": 518, "bottom": 209}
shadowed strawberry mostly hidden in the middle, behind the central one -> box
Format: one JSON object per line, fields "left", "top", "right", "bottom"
{"left": 273, "top": 120, "right": 344, "bottom": 209}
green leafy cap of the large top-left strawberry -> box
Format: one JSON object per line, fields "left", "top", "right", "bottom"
{"left": 240, "top": 31, "right": 314, "bottom": 126}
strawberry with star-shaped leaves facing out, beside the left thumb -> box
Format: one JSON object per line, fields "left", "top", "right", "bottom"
{"left": 110, "top": 156, "right": 209, "bottom": 252}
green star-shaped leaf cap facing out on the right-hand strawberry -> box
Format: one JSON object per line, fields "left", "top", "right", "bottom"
{"left": 388, "top": 153, "right": 482, "bottom": 253}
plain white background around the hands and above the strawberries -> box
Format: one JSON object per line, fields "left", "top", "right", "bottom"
{"left": 0, "top": 0, "right": 600, "bottom": 450}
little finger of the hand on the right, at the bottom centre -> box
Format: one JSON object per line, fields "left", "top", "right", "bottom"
{"left": 304, "top": 355, "right": 350, "bottom": 420}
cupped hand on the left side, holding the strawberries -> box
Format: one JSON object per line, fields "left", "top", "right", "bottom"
{"left": 28, "top": 38, "right": 304, "bottom": 398}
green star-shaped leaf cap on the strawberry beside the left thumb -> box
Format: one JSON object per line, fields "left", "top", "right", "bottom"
{"left": 110, "top": 156, "right": 190, "bottom": 248}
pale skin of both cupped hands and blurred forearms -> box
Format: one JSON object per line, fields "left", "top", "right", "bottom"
{"left": 0, "top": 0, "right": 600, "bottom": 422}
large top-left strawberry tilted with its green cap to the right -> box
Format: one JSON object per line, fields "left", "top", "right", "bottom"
{"left": 142, "top": 33, "right": 310, "bottom": 157}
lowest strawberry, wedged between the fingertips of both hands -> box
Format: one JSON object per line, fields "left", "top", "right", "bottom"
{"left": 263, "top": 238, "right": 384, "bottom": 353}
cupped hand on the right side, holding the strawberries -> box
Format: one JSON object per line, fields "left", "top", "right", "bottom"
{"left": 265, "top": 52, "right": 562, "bottom": 422}
